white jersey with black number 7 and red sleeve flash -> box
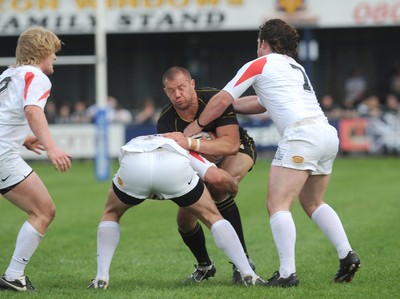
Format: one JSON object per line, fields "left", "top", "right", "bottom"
{"left": 223, "top": 53, "right": 324, "bottom": 135}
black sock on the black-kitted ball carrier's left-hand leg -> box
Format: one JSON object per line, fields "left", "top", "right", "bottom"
{"left": 179, "top": 222, "right": 211, "bottom": 266}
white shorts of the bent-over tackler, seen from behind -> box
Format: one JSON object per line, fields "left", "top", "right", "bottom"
{"left": 113, "top": 148, "right": 200, "bottom": 199}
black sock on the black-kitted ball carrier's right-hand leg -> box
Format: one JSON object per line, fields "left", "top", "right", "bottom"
{"left": 215, "top": 197, "right": 249, "bottom": 258}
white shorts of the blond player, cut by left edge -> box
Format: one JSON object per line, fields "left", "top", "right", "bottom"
{"left": 0, "top": 153, "right": 32, "bottom": 190}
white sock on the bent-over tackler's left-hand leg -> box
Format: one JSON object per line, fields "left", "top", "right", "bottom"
{"left": 96, "top": 221, "right": 120, "bottom": 282}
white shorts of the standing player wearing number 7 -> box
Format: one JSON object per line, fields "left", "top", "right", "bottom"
{"left": 272, "top": 121, "right": 339, "bottom": 175}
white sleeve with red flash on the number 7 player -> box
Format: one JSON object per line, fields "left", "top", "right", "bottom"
{"left": 223, "top": 56, "right": 267, "bottom": 100}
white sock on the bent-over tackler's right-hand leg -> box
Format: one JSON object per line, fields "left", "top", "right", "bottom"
{"left": 211, "top": 219, "right": 256, "bottom": 277}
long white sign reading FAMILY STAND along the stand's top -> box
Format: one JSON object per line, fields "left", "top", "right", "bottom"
{"left": 0, "top": 0, "right": 400, "bottom": 35}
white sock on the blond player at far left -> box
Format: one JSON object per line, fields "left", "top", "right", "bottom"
{"left": 5, "top": 221, "right": 43, "bottom": 280}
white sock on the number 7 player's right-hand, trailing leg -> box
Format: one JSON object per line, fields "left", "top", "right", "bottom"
{"left": 311, "top": 204, "right": 351, "bottom": 259}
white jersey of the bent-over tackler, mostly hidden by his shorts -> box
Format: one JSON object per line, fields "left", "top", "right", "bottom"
{"left": 119, "top": 135, "right": 216, "bottom": 180}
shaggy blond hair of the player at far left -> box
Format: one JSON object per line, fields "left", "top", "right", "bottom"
{"left": 15, "top": 27, "right": 63, "bottom": 66}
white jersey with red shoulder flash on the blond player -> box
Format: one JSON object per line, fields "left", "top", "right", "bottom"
{"left": 0, "top": 65, "right": 51, "bottom": 155}
